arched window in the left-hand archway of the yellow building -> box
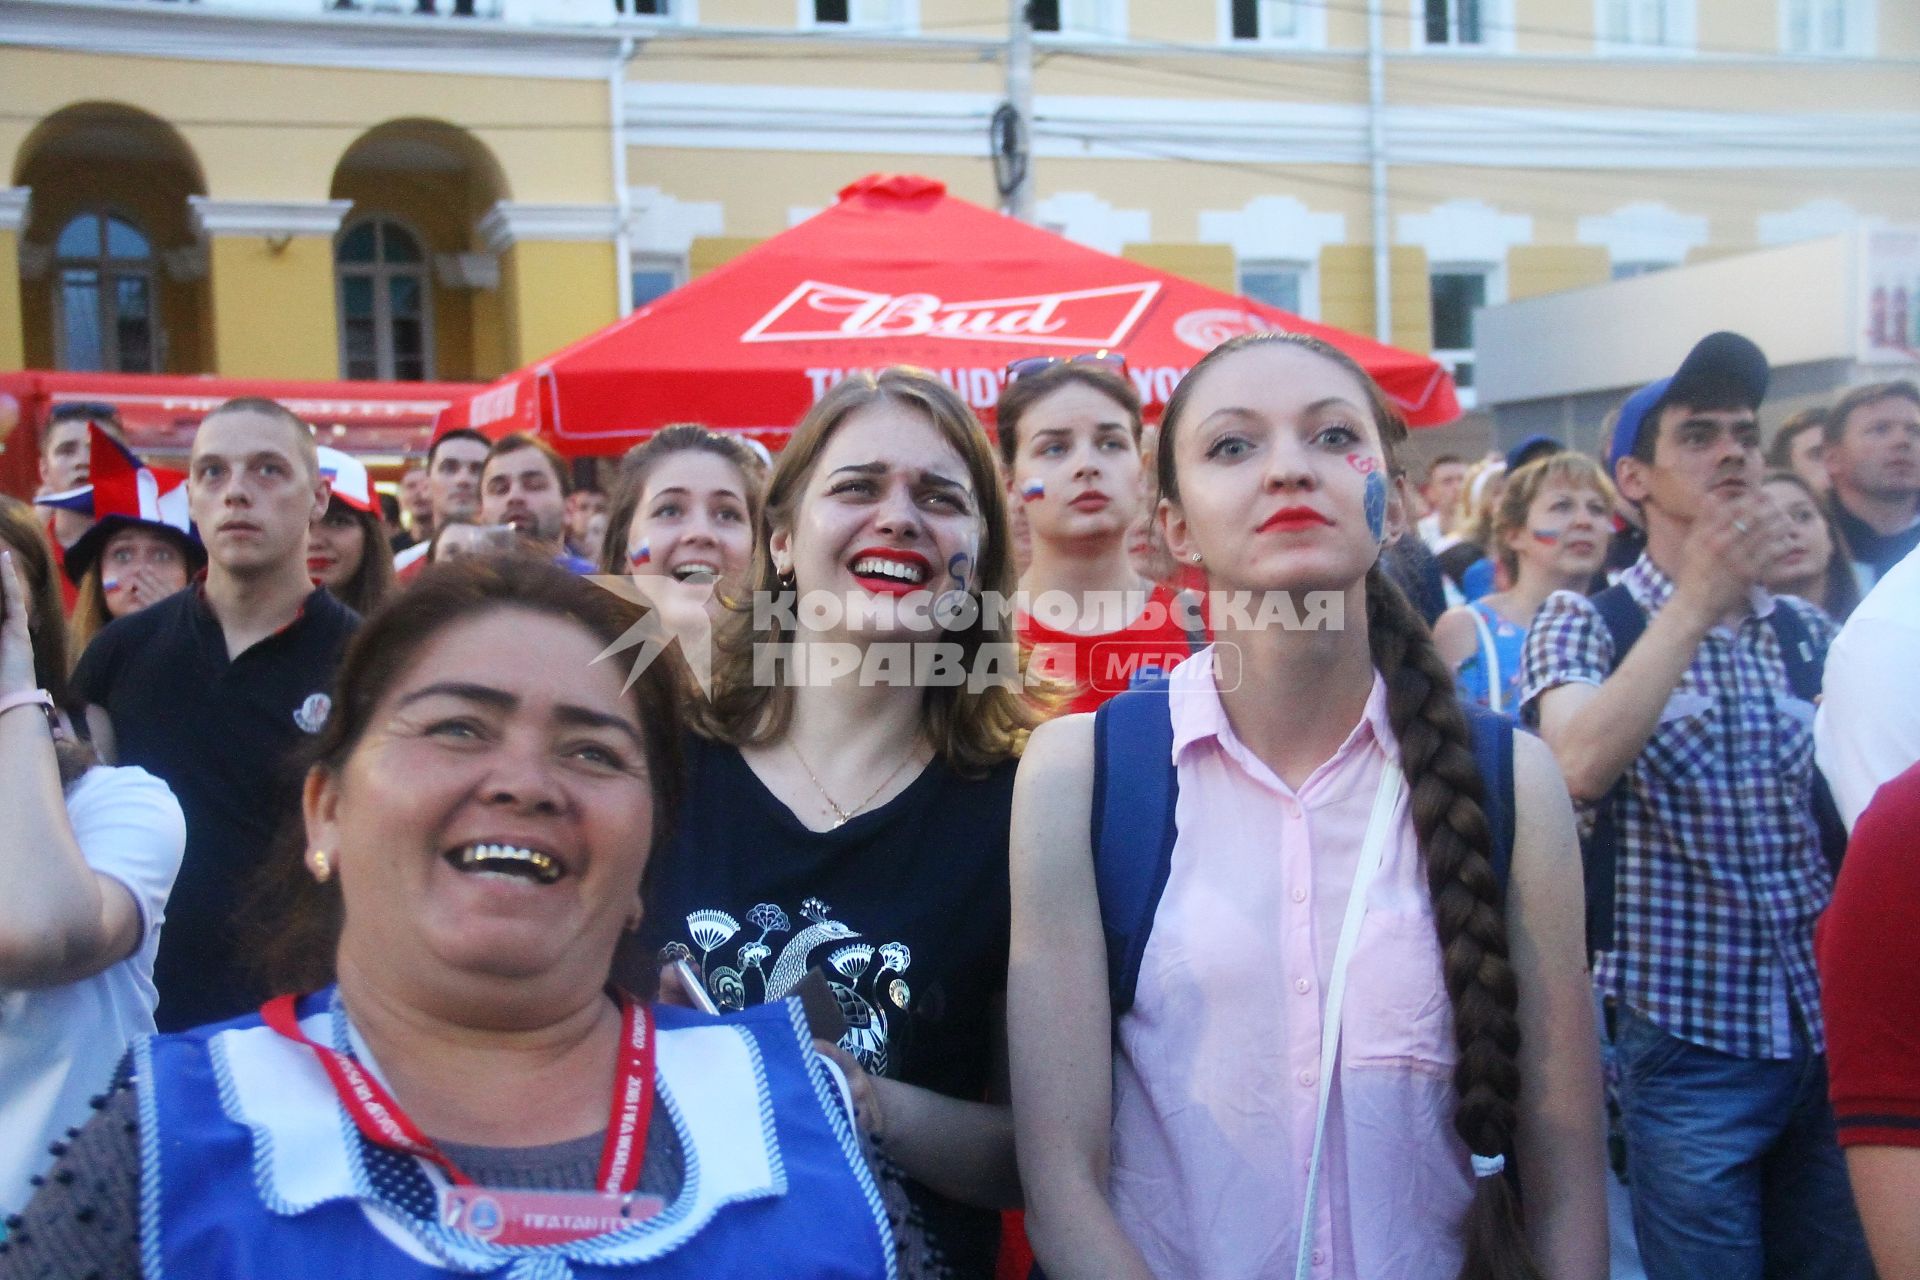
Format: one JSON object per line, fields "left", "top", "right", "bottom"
{"left": 54, "top": 213, "right": 159, "bottom": 374}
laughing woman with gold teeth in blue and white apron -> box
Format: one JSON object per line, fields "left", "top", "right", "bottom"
{"left": 0, "top": 557, "right": 891, "bottom": 1280}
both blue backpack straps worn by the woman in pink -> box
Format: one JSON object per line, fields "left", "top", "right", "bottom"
{"left": 1092, "top": 676, "right": 1515, "bottom": 1019}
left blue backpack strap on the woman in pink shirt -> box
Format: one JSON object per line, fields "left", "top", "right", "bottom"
{"left": 1091, "top": 676, "right": 1179, "bottom": 1019}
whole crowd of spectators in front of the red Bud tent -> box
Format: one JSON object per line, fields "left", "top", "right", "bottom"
{"left": 0, "top": 334, "right": 1920, "bottom": 1280}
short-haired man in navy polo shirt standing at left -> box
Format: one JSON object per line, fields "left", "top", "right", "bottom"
{"left": 73, "top": 399, "right": 359, "bottom": 1031}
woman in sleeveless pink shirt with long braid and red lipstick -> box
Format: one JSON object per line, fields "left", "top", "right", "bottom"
{"left": 1008, "top": 334, "right": 1607, "bottom": 1280}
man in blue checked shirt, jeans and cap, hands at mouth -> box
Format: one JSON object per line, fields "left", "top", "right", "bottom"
{"left": 1521, "top": 334, "right": 1872, "bottom": 1280}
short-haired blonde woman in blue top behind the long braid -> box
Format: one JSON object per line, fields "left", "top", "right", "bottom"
{"left": 1434, "top": 453, "right": 1613, "bottom": 716}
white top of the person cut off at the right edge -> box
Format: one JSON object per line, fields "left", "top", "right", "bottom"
{"left": 1812, "top": 547, "right": 1920, "bottom": 831}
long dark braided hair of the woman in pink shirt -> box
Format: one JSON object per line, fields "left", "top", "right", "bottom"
{"left": 1156, "top": 334, "right": 1542, "bottom": 1280}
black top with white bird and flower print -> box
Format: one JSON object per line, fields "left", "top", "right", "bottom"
{"left": 643, "top": 739, "right": 1016, "bottom": 1276}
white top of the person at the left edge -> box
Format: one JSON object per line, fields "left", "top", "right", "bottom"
{"left": 0, "top": 766, "right": 186, "bottom": 1217}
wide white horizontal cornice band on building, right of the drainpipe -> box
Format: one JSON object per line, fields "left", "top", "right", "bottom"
{"left": 626, "top": 83, "right": 1920, "bottom": 171}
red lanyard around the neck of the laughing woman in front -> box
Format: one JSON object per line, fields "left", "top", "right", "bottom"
{"left": 259, "top": 992, "right": 653, "bottom": 1196}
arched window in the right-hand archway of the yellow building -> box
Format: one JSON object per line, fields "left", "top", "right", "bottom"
{"left": 334, "top": 217, "right": 434, "bottom": 382}
